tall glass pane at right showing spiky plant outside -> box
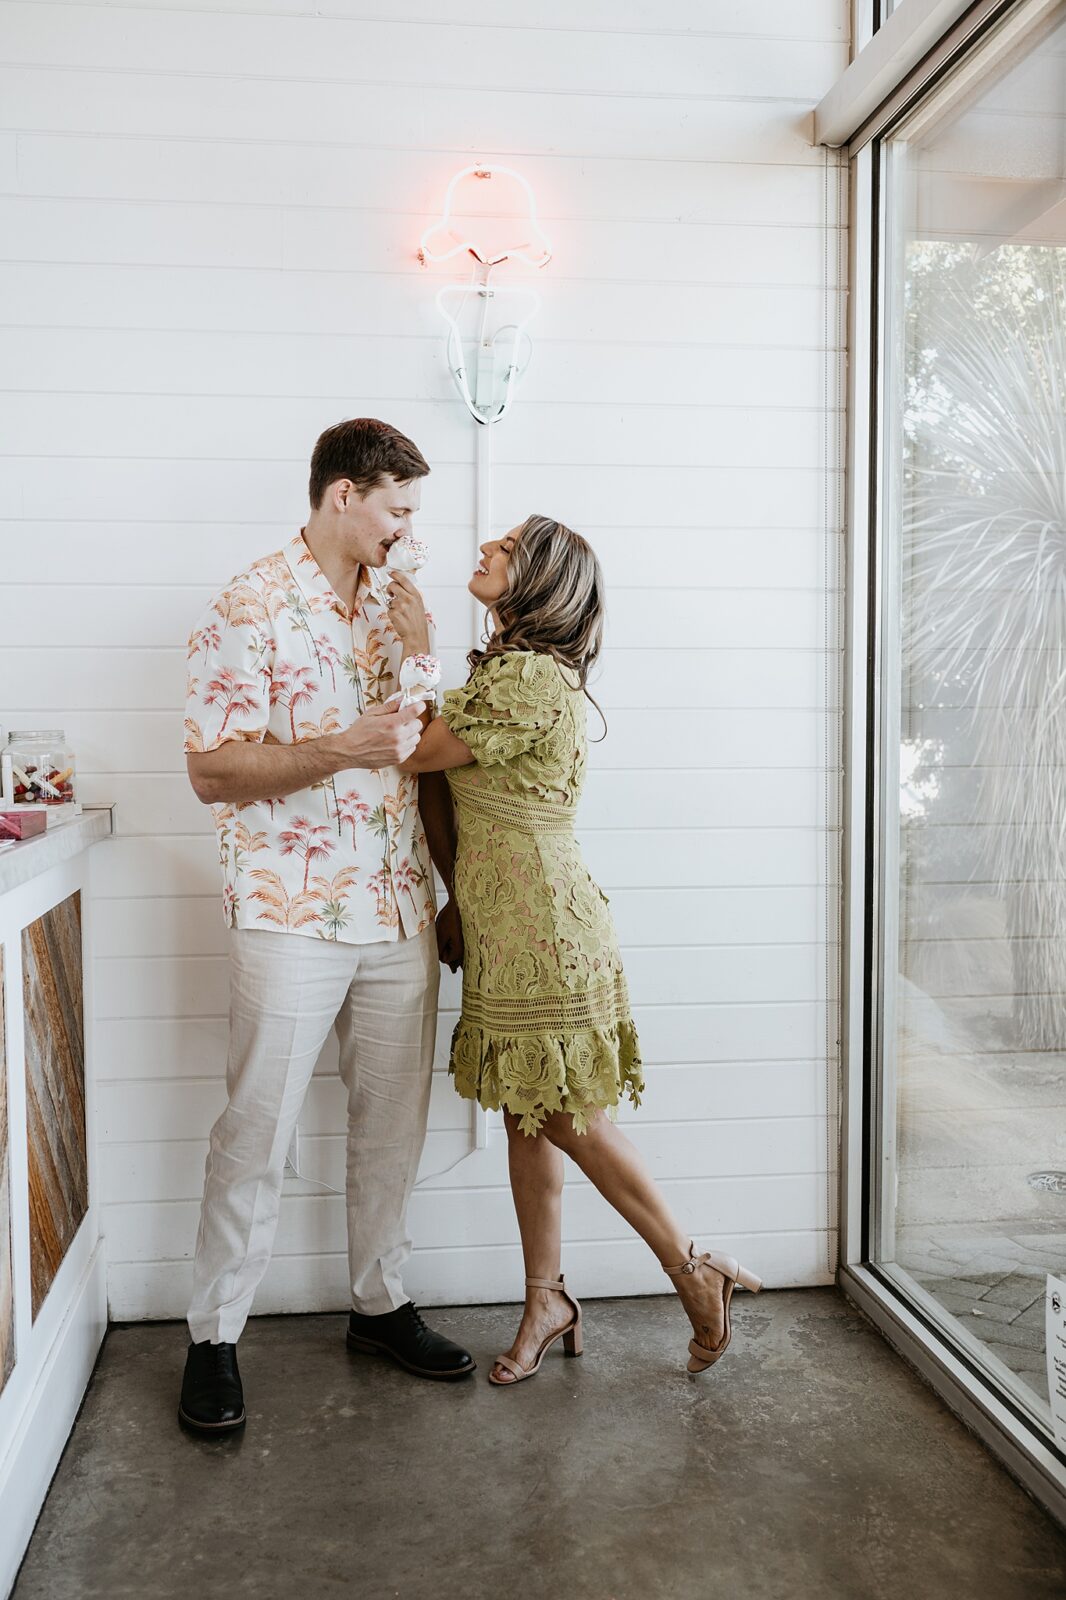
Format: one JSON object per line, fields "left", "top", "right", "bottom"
{"left": 869, "top": 8, "right": 1066, "bottom": 1432}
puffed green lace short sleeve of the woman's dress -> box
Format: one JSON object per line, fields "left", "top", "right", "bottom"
{"left": 440, "top": 651, "right": 570, "bottom": 766}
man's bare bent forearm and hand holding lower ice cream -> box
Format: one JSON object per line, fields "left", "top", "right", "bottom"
{"left": 186, "top": 706, "right": 423, "bottom": 805}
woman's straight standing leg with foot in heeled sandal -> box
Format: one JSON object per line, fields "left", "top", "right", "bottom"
{"left": 493, "top": 1112, "right": 571, "bottom": 1382}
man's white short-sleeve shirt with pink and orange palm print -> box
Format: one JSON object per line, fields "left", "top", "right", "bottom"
{"left": 184, "top": 534, "right": 435, "bottom": 944}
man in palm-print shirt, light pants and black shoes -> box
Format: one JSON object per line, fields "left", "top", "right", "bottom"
{"left": 179, "top": 418, "right": 474, "bottom": 1434}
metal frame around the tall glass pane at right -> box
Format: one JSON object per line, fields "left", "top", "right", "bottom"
{"left": 837, "top": 0, "right": 1066, "bottom": 1523}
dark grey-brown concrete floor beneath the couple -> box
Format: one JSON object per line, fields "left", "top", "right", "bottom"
{"left": 14, "top": 1290, "right": 1066, "bottom": 1600}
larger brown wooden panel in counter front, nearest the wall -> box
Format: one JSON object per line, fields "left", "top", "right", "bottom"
{"left": 22, "top": 893, "right": 88, "bottom": 1317}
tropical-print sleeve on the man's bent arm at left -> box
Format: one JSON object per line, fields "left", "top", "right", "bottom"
{"left": 184, "top": 589, "right": 272, "bottom": 755}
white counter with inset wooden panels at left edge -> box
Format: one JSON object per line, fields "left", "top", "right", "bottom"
{"left": 0, "top": 793, "right": 114, "bottom": 1595}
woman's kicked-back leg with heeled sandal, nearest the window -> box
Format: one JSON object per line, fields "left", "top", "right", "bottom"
{"left": 538, "top": 1110, "right": 725, "bottom": 1347}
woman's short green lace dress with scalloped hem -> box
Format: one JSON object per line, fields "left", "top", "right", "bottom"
{"left": 442, "top": 650, "right": 643, "bottom": 1133}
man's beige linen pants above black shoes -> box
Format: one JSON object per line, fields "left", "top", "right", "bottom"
{"left": 189, "top": 926, "right": 440, "bottom": 1344}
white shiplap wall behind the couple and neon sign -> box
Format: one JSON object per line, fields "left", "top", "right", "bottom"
{"left": 0, "top": 0, "right": 848, "bottom": 1318}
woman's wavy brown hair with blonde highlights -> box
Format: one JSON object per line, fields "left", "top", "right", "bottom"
{"left": 466, "top": 515, "right": 607, "bottom": 731}
